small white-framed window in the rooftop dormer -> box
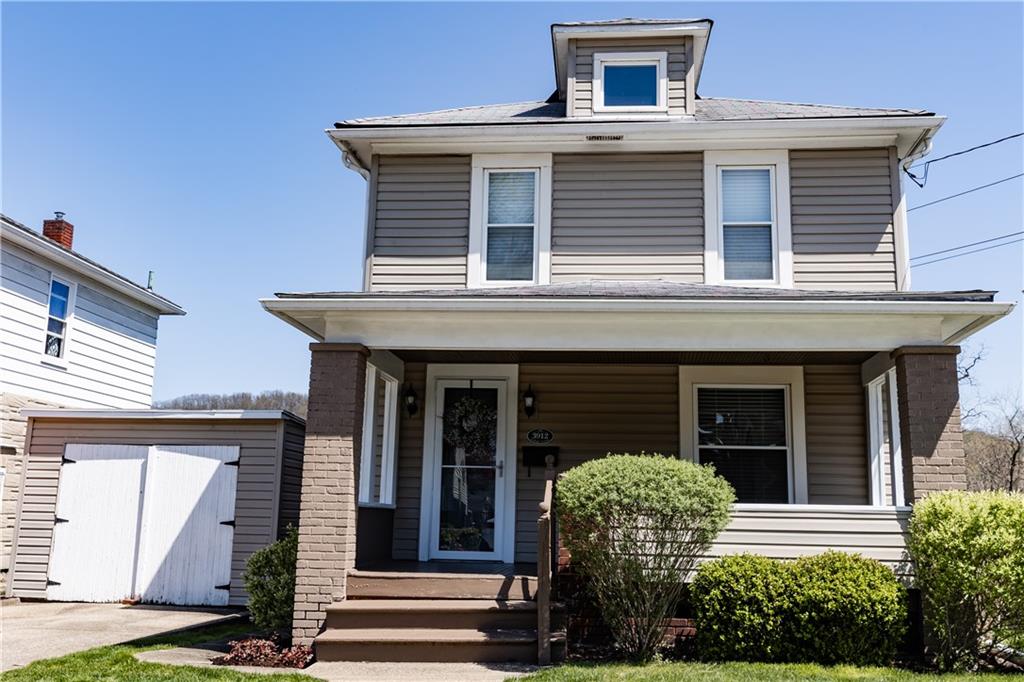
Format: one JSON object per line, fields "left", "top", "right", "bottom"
{"left": 593, "top": 52, "right": 669, "bottom": 114}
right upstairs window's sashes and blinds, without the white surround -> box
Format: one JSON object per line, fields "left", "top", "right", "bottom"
{"left": 721, "top": 168, "right": 775, "bottom": 281}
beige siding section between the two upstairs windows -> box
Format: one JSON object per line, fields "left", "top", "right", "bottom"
{"left": 551, "top": 153, "right": 703, "bottom": 283}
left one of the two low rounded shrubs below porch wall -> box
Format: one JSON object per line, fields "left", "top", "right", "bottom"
{"left": 690, "top": 554, "right": 791, "bottom": 663}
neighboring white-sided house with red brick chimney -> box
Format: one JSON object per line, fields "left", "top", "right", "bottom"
{"left": 0, "top": 213, "right": 184, "bottom": 579}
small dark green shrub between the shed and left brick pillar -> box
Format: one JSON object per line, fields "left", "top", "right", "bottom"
{"left": 242, "top": 526, "right": 299, "bottom": 630}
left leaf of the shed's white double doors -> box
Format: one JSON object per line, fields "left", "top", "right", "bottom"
{"left": 46, "top": 444, "right": 150, "bottom": 601}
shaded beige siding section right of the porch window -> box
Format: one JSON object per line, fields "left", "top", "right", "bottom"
{"left": 804, "top": 365, "right": 870, "bottom": 505}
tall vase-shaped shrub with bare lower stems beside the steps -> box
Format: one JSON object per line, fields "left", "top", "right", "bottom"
{"left": 557, "top": 454, "right": 735, "bottom": 660}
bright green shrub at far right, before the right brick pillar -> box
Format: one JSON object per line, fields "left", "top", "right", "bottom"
{"left": 907, "top": 492, "right": 1024, "bottom": 670}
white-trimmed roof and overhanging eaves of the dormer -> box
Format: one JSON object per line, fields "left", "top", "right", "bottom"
{"left": 551, "top": 17, "right": 715, "bottom": 101}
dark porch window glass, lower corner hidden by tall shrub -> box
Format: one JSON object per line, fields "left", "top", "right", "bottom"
{"left": 697, "top": 387, "right": 790, "bottom": 503}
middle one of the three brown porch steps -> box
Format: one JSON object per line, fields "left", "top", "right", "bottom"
{"left": 325, "top": 599, "right": 564, "bottom": 630}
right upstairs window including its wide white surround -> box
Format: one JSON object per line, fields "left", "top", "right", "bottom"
{"left": 705, "top": 152, "right": 793, "bottom": 287}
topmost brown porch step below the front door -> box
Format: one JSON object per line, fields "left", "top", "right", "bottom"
{"left": 346, "top": 569, "right": 537, "bottom": 600}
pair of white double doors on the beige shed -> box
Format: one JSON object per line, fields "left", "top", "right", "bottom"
{"left": 47, "top": 444, "right": 239, "bottom": 605}
